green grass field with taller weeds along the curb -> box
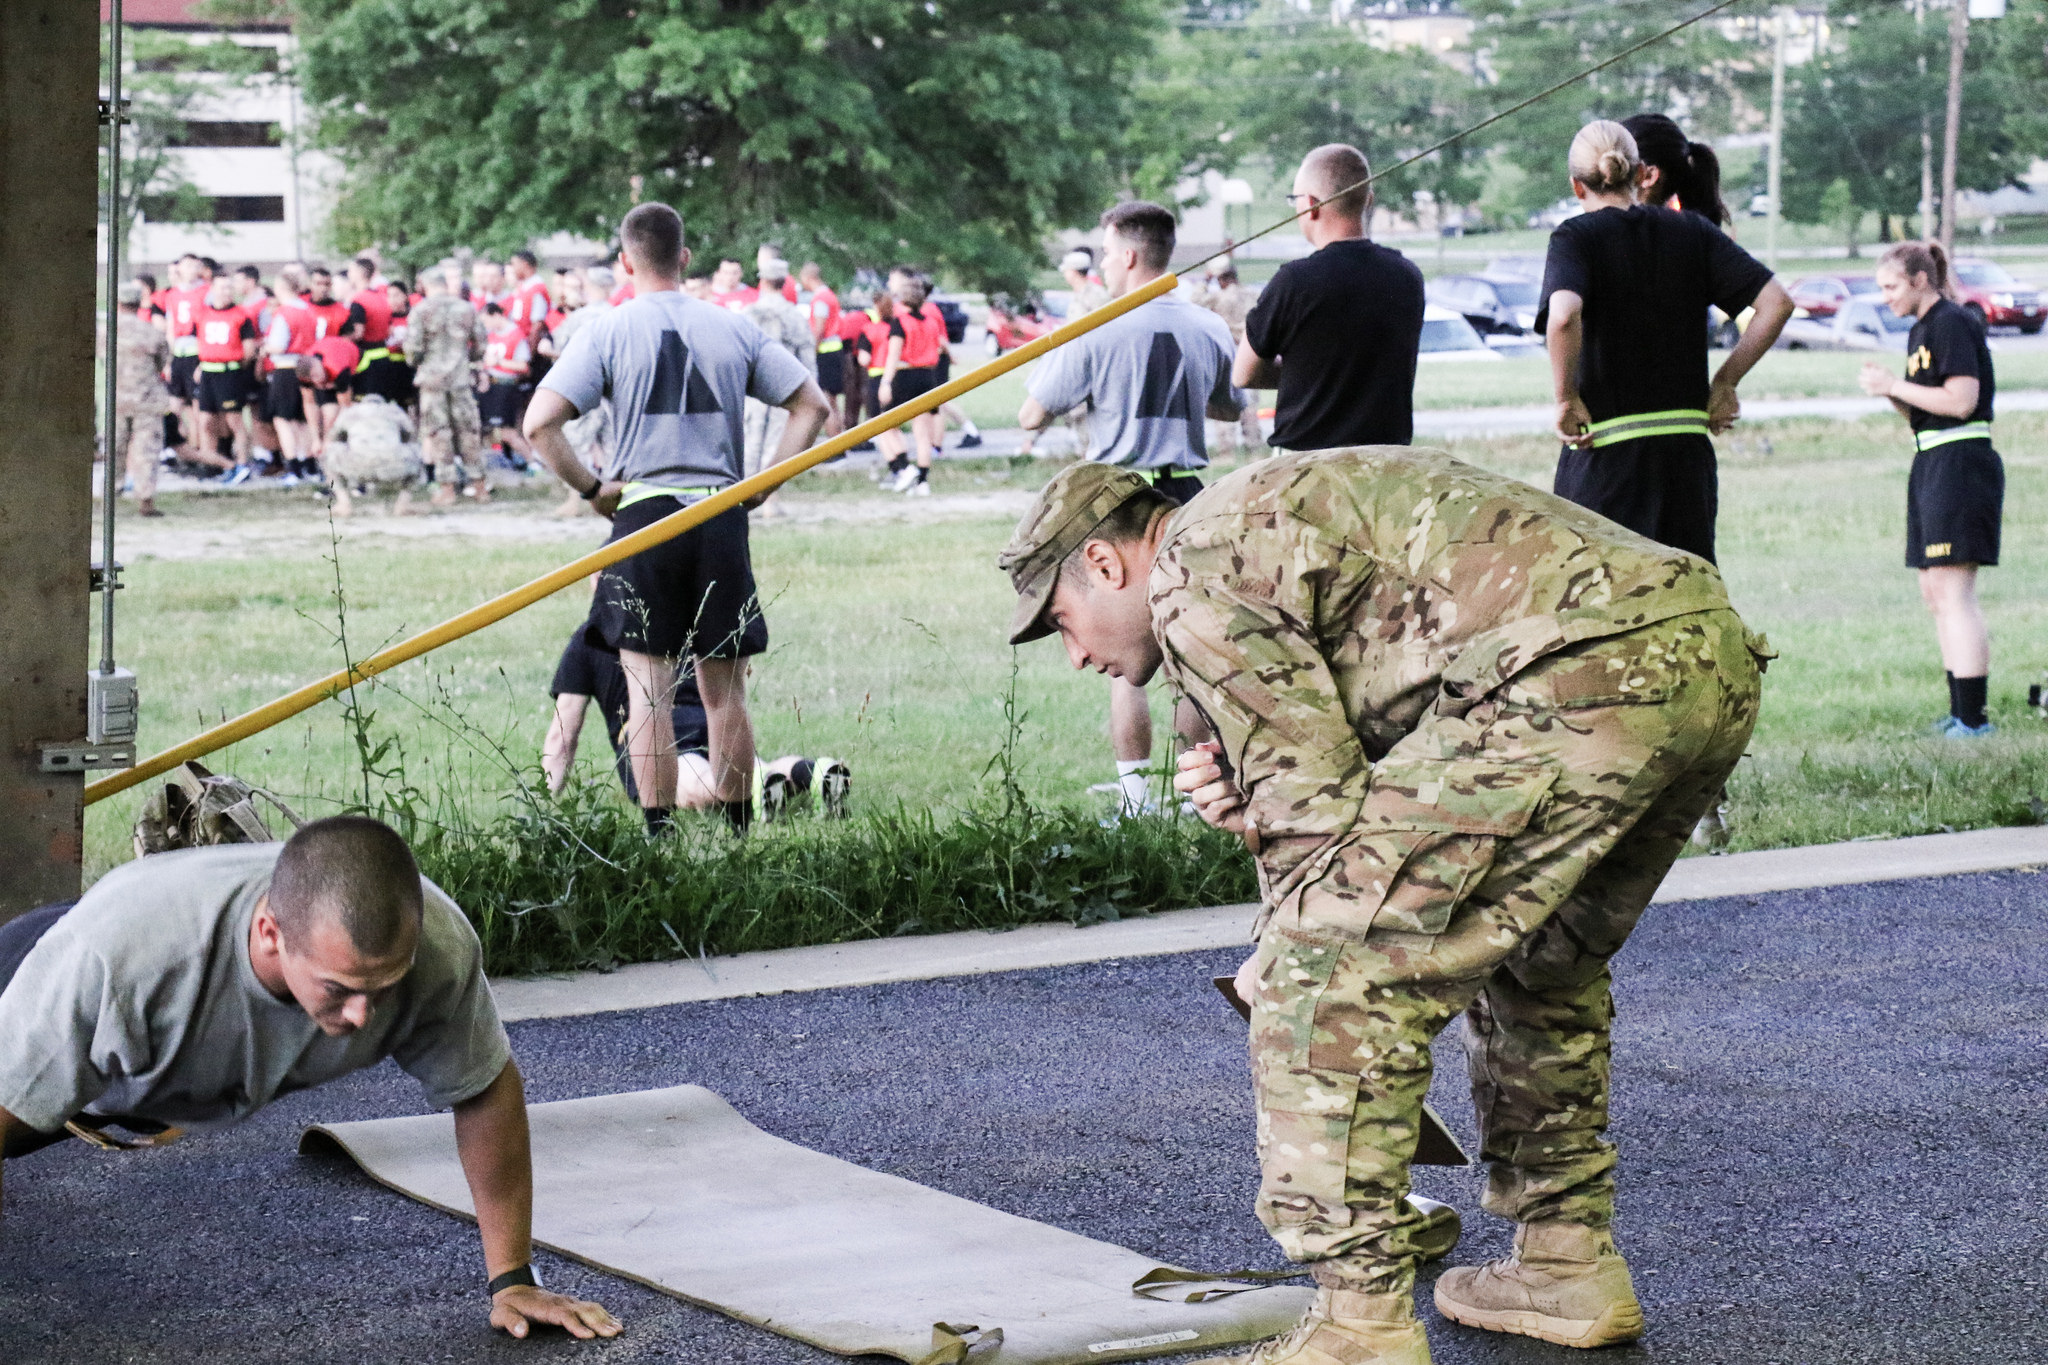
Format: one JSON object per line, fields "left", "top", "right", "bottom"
{"left": 86, "top": 419, "right": 2048, "bottom": 968}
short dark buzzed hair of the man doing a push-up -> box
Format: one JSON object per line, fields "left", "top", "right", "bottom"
{"left": 270, "top": 814, "right": 424, "bottom": 958}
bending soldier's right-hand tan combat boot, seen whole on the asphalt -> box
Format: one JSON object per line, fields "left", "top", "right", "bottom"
{"left": 1436, "top": 1222, "right": 1642, "bottom": 1349}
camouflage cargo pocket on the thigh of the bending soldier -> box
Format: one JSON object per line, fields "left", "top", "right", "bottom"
{"left": 1300, "top": 757, "right": 1556, "bottom": 935}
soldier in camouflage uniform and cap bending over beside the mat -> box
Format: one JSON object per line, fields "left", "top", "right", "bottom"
{"left": 1001, "top": 446, "right": 1767, "bottom": 1365}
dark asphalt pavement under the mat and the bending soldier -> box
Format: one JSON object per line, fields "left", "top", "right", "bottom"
{"left": 0, "top": 872, "right": 2048, "bottom": 1365}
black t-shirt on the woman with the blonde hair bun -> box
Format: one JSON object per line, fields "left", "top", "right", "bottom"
{"left": 1536, "top": 205, "right": 1772, "bottom": 422}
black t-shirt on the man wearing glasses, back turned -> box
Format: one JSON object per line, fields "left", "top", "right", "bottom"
{"left": 1245, "top": 237, "right": 1423, "bottom": 450}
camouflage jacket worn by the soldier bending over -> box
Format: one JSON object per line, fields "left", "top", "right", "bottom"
{"left": 1149, "top": 446, "right": 1729, "bottom": 929}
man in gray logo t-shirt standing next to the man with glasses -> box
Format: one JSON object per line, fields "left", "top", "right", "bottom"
{"left": 1018, "top": 203, "right": 1245, "bottom": 814}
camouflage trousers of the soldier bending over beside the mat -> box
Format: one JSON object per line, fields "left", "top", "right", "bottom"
{"left": 1251, "top": 610, "right": 1765, "bottom": 1293}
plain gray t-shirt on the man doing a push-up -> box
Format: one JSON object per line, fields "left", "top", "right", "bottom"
{"left": 0, "top": 843, "right": 512, "bottom": 1132}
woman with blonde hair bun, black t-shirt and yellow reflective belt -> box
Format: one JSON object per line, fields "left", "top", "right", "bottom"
{"left": 1536, "top": 119, "right": 1792, "bottom": 563}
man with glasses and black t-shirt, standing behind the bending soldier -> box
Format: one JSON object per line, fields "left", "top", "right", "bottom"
{"left": 1231, "top": 143, "right": 1423, "bottom": 450}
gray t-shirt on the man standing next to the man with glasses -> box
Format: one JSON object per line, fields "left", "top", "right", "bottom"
{"left": 1028, "top": 295, "right": 1245, "bottom": 469}
